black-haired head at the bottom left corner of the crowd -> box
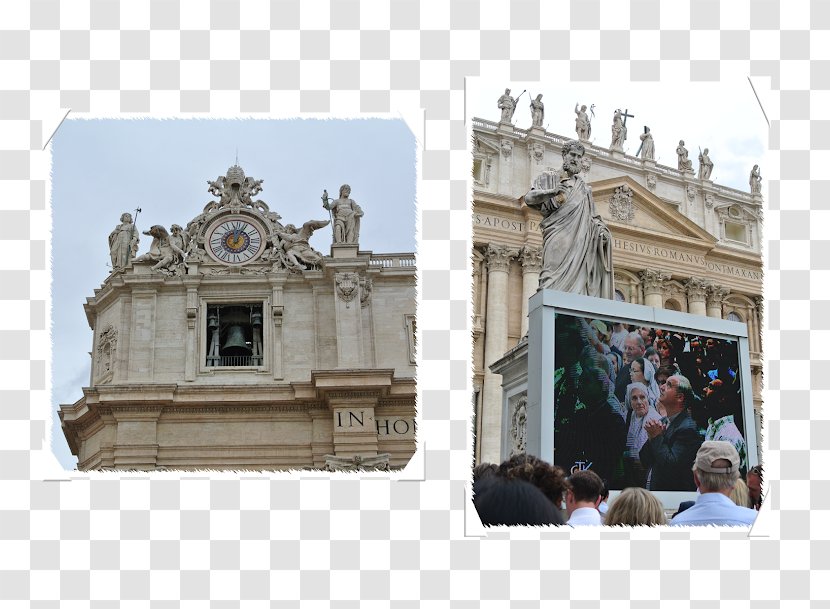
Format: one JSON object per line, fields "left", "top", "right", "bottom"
{"left": 473, "top": 476, "right": 562, "bottom": 526}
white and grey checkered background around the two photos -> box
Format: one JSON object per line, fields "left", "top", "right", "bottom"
{"left": 0, "top": 0, "right": 830, "bottom": 608}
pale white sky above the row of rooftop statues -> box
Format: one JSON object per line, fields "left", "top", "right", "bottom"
{"left": 467, "top": 79, "right": 769, "bottom": 192}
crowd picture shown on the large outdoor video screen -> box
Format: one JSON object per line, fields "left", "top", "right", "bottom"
{"left": 554, "top": 315, "right": 749, "bottom": 491}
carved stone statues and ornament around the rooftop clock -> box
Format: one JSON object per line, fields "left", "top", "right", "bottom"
{"left": 108, "top": 165, "right": 363, "bottom": 276}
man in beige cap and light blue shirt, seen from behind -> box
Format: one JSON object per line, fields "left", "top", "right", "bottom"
{"left": 669, "top": 441, "right": 758, "bottom": 527}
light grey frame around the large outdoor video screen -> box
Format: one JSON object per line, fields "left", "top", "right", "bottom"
{"left": 526, "top": 290, "right": 759, "bottom": 509}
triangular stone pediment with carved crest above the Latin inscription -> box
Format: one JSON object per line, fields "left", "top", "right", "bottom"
{"left": 591, "top": 176, "right": 717, "bottom": 247}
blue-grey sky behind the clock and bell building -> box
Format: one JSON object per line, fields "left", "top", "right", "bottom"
{"left": 51, "top": 118, "right": 417, "bottom": 469}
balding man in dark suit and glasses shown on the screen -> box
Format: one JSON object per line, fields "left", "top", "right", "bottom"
{"left": 640, "top": 374, "right": 703, "bottom": 491}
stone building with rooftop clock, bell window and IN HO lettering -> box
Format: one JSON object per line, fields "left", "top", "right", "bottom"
{"left": 59, "top": 166, "right": 416, "bottom": 470}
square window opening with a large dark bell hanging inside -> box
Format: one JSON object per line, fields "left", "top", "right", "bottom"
{"left": 205, "top": 303, "right": 262, "bottom": 368}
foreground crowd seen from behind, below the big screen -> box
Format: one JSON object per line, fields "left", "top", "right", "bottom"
{"left": 473, "top": 440, "right": 761, "bottom": 527}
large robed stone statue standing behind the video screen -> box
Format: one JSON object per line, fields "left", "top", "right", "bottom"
{"left": 524, "top": 141, "right": 614, "bottom": 299}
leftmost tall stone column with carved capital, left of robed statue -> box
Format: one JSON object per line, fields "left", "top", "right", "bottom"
{"left": 481, "top": 245, "right": 516, "bottom": 463}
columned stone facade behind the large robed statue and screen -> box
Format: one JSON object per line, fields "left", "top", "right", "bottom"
{"left": 473, "top": 118, "right": 763, "bottom": 462}
